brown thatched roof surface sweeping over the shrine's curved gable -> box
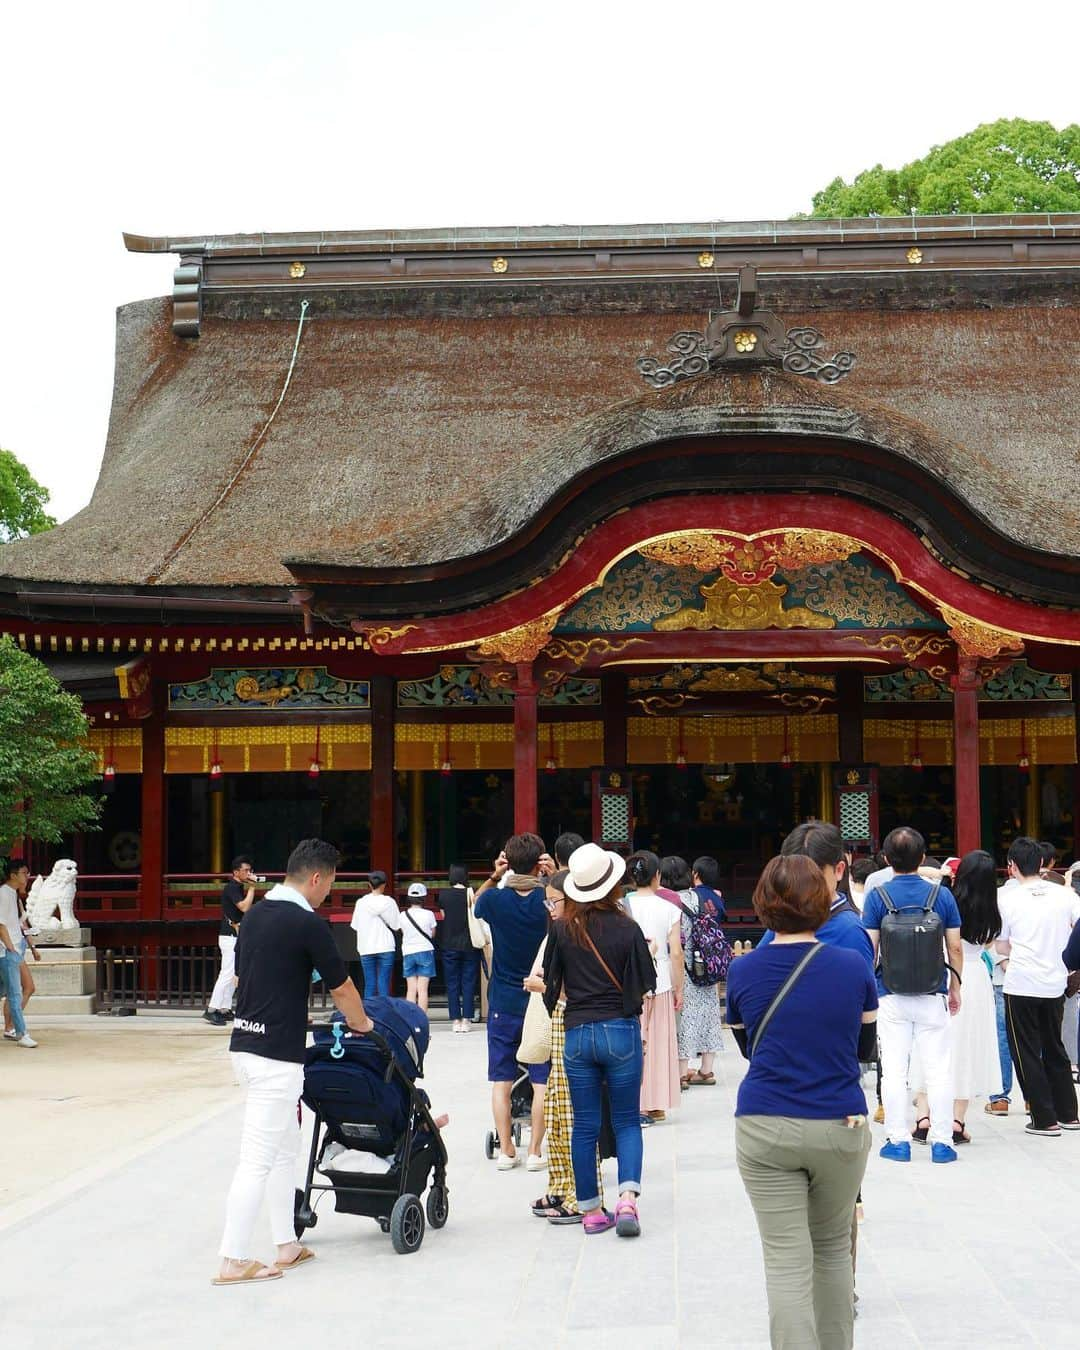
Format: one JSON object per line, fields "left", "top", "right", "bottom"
{"left": 0, "top": 273, "right": 1080, "bottom": 589}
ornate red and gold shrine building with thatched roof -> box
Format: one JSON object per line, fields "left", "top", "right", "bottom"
{"left": 0, "top": 215, "right": 1080, "bottom": 961}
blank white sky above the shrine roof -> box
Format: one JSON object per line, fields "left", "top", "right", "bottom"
{"left": 0, "top": 0, "right": 1080, "bottom": 523}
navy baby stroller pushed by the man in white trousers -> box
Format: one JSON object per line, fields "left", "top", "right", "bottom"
{"left": 294, "top": 998, "right": 450, "bottom": 1256}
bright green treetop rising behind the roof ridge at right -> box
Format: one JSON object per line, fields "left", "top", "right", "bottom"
{"left": 810, "top": 117, "right": 1080, "bottom": 216}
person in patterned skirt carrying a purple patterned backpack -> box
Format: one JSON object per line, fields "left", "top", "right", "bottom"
{"left": 660, "top": 857, "right": 732, "bottom": 1091}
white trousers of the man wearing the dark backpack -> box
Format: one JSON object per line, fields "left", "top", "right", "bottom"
{"left": 878, "top": 994, "right": 953, "bottom": 1145}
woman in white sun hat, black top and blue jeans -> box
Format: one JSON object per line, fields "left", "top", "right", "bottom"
{"left": 544, "top": 844, "right": 656, "bottom": 1238}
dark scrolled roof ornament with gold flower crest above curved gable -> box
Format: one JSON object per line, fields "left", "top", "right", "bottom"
{"left": 637, "top": 263, "right": 855, "bottom": 389}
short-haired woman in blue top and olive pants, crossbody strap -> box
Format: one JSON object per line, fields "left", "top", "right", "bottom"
{"left": 728, "top": 855, "right": 878, "bottom": 1350}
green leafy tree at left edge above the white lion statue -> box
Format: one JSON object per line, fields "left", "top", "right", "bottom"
{"left": 0, "top": 635, "right": 101, "bottom": 853}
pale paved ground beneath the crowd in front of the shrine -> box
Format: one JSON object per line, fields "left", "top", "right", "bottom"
{"left": 0, "top": 1018, "right": 1080, "bottom": 1350}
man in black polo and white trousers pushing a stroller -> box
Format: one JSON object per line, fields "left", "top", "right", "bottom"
{"left": 212, "top": 840, "right": 373, "bottom": 1284}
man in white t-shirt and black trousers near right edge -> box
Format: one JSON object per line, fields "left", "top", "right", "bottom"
{"left": 998, "top": 834, "right": 1080, "bottom": 1137}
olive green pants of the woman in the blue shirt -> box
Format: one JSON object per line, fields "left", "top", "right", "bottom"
{"left": 734, "top": 1115, "right": 871, "bottom": 1350}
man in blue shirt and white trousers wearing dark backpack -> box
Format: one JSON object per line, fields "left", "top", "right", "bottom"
{"left": 863, "top": 825, "right": 964, "bottom": 1162}
